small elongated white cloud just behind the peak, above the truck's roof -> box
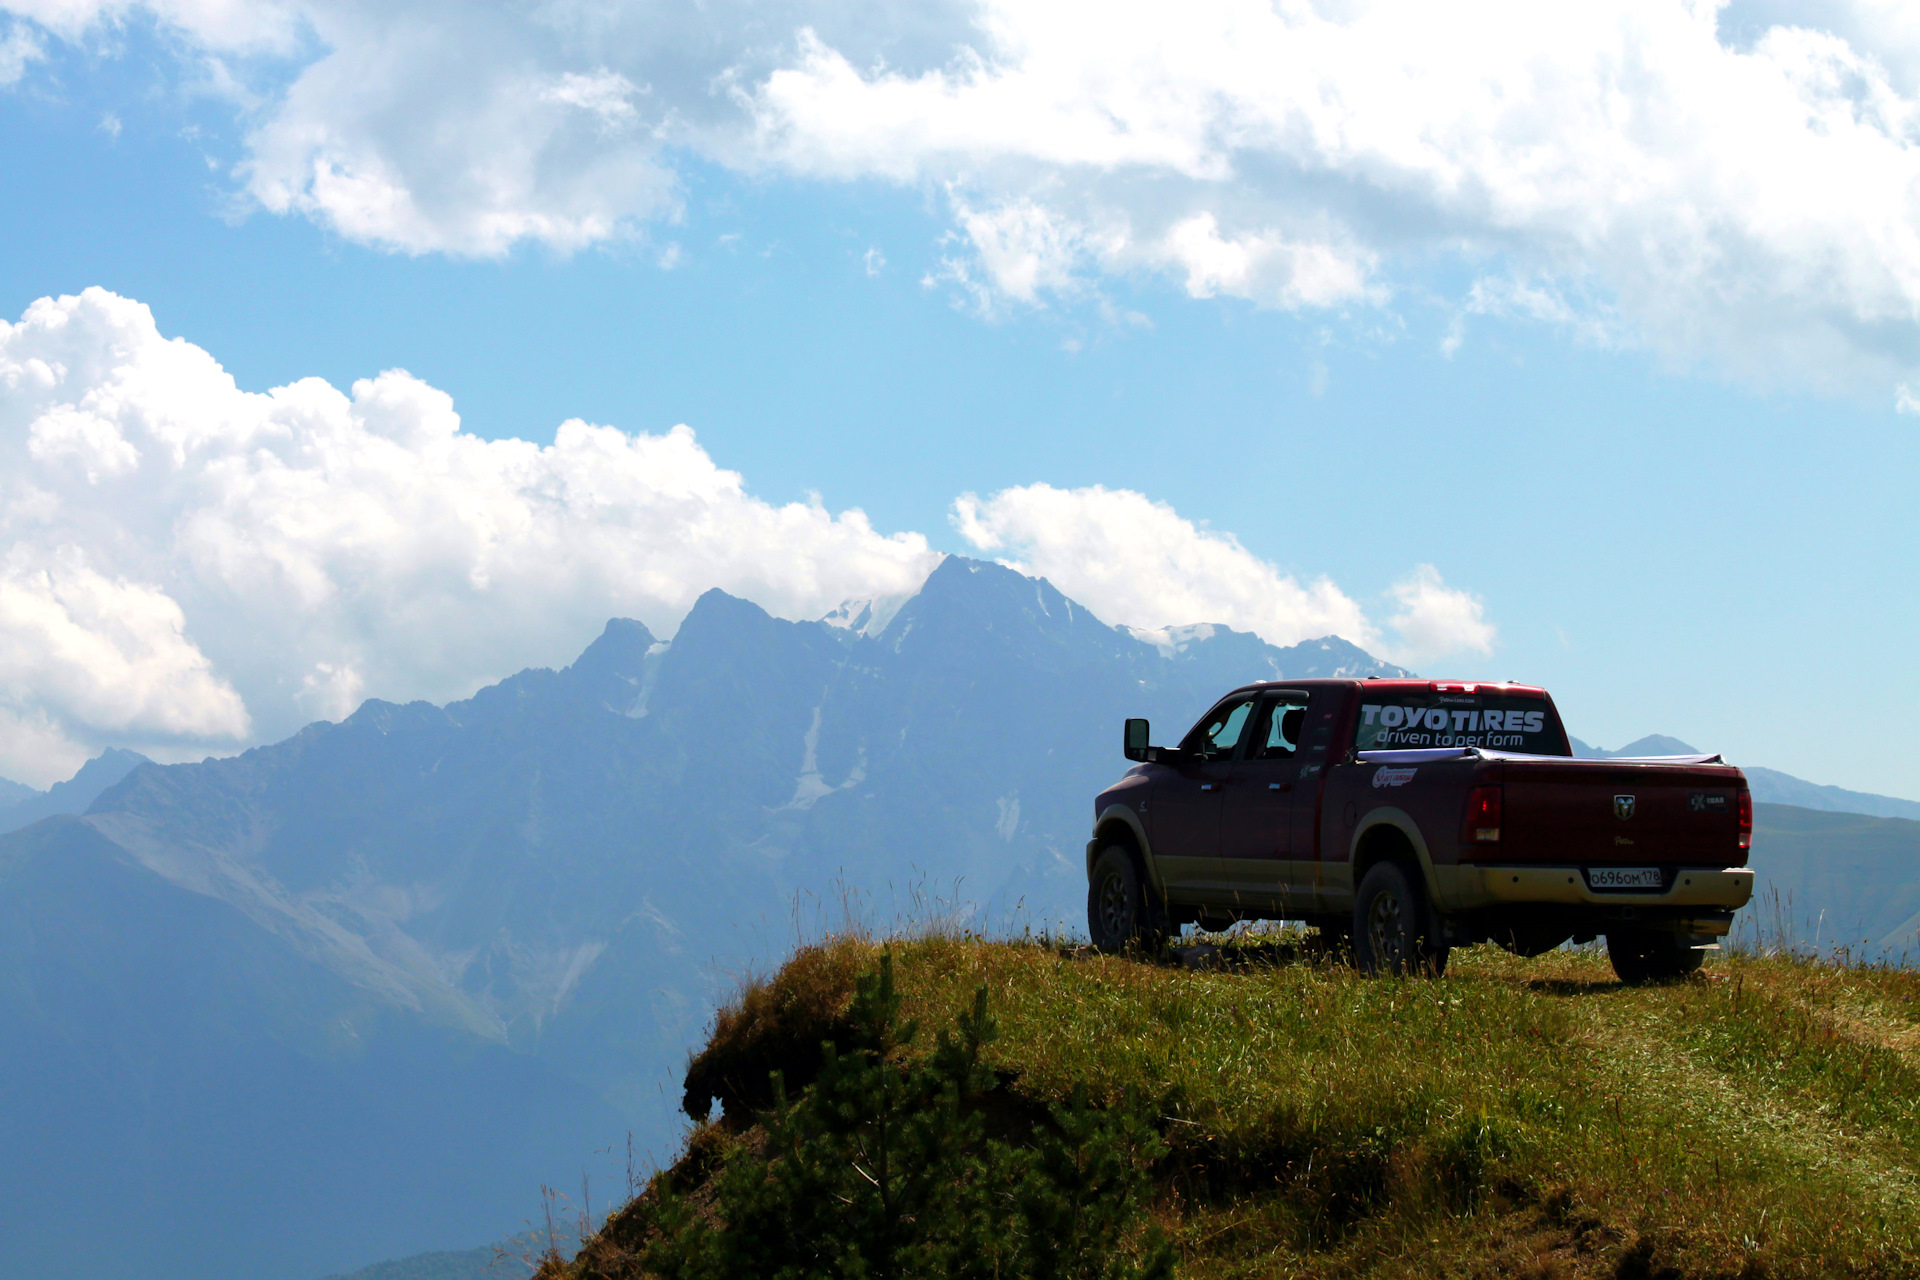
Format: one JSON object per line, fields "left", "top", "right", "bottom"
{"left": 952, "top": 484, "right": 1494, "bottom": 664}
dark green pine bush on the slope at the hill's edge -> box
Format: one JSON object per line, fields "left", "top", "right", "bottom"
{"left": 637, "top": 952, "right": 1173, "bottom": 1280}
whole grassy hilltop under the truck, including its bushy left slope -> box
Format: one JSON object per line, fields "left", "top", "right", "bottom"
{"left": 543, "top": 935, "right": 1920, "bottom": 1280}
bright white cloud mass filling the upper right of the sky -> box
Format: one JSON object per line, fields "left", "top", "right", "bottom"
{"left": 755, "top": 0, "right": 1920, "bottom": 384}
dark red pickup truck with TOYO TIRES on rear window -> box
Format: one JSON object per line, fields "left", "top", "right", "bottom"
{"left": 1087, "top": 679, "right": 1753, "bottom": 983}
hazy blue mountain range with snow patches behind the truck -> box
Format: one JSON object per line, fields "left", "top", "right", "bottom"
{"left": 0, "top": 557, "right": 1920, "bottom": 1280}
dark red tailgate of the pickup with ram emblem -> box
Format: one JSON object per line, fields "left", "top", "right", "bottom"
{"left": 1500, "top": 758, "right": 1747, "bottom": 867}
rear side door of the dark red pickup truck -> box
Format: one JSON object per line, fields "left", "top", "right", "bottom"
{"left": 1219, "top": 691, "right": 1317, "bottom": 917}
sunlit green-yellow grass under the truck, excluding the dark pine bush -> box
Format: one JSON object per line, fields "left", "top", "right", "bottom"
{"left": 551, "top": 936, "right": 1920, "bottom": 1280}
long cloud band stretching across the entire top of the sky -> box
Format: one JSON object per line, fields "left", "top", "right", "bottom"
{"left": 0, "top": 0, "right": 1920, "bottom": 395}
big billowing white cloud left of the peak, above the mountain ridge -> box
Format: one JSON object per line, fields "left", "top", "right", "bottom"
{"left": 0, "top": 290, "right": 937, "bottom": 783}
